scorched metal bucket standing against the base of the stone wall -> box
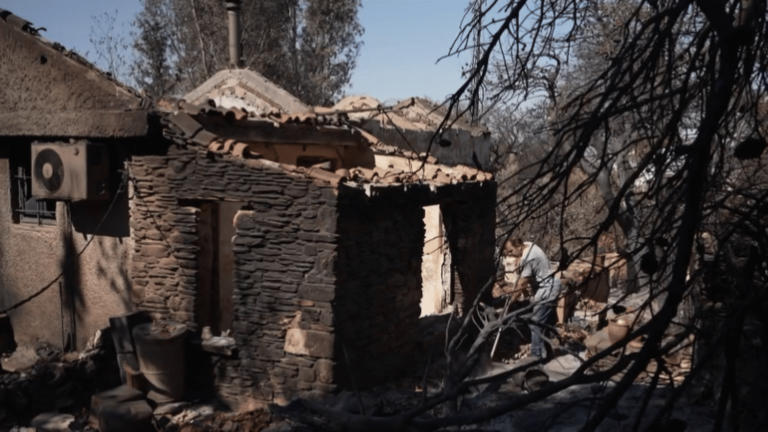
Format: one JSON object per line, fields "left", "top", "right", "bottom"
{"left": 133, "top": 322, "right": 187, "bottom": 403}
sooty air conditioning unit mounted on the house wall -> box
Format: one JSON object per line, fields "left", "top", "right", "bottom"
{"left": 32, "top": 141, "right": 109, "bottom": 201}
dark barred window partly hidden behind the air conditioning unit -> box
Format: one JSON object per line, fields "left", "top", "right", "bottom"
{"left": 10, "top": 146, "right": 56, "bottom": 225}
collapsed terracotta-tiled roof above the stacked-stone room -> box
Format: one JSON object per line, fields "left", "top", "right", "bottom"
{"left": 163, "top": 100, "right": 493, "bottom": 187}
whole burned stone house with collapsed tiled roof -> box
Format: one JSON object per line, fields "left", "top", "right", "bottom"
{"left": 0, "top": 7, "right": 496, "bottom": 403}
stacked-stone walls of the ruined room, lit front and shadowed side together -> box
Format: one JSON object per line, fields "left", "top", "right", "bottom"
{"left": 130, "top": 141, "right": 495, "bottom": 403}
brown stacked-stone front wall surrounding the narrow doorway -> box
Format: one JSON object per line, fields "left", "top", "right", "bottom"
{"left": 131, "top": 146, "right": 336, "bottom": 402}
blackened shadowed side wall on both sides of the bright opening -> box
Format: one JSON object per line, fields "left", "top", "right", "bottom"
{"left": 335, "top": 182, "right": 496, "bottom": 387}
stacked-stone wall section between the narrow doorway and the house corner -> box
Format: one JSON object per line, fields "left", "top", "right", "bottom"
{"left": 224, "top": 177, "right": 336, "bottom": 401}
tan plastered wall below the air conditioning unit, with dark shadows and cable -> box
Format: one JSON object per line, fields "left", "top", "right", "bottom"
{"left": 0, "top": 152, "right": 132, "bottom": 349}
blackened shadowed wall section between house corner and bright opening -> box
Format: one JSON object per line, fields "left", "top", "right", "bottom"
{"left": 336, "top": 187, "right": 426, "bottom": 386}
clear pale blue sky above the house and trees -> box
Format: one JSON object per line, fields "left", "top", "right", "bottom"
{"left": 0, "top": 0, "right": 469, "bottom": 101}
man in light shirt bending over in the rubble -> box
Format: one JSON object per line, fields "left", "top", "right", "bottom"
{"left": 502, "top": 237, "right": 561, "bottom": 358}
